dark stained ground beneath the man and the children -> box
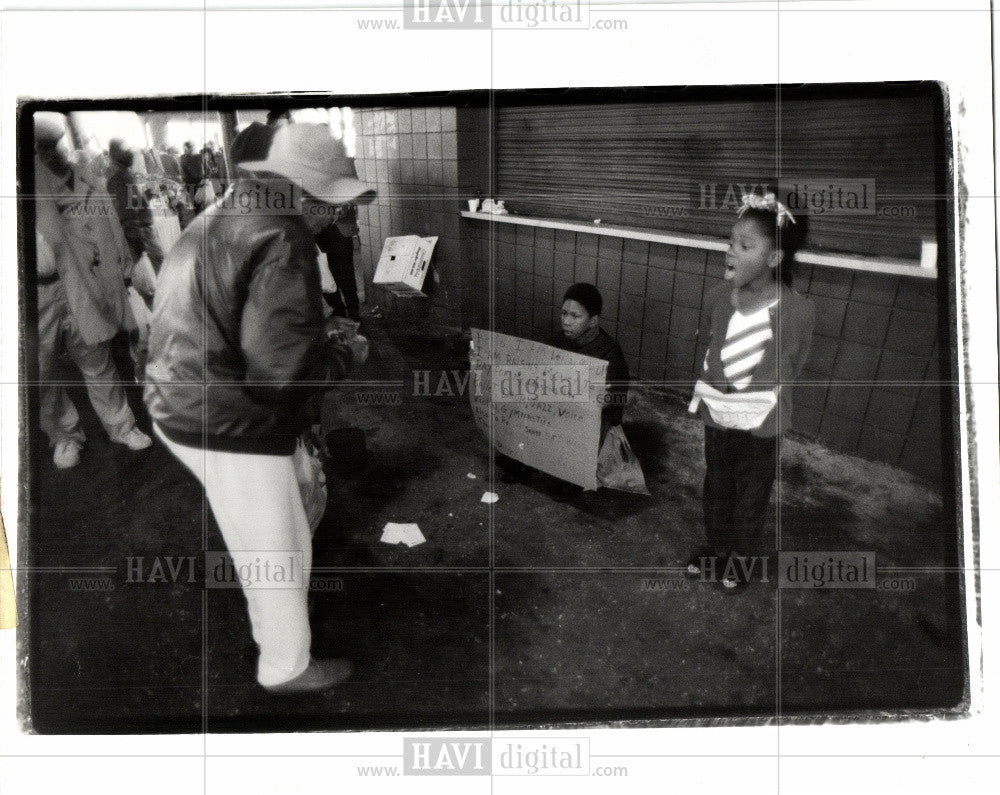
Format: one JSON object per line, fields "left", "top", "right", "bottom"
{"left": 20, "top": 318, "right": 965, "bottom": 732}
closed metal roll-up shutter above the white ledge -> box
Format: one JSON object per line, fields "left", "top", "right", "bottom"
{"left": 496, "top": 88, "right": 938, "bottom": 259}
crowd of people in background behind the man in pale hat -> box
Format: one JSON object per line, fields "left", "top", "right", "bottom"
{"left": 34, "top": 112, "right": 368, "bottom": 469}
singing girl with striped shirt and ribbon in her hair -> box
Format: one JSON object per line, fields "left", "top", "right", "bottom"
{"left": 686, "top": 194, "right": 814, "bottom": 593}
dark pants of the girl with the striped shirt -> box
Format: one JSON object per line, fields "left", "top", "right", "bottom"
{"left": 702, "top": 425, "right": 778, "bottom": 555}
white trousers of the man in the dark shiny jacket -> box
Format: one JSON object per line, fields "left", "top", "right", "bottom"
{"left": 154, "top": 425, "right": 312, "bottom": 687}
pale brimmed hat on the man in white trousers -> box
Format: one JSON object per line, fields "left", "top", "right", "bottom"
{"left": 241, "top": 124, "right": 375, "bottom": 205}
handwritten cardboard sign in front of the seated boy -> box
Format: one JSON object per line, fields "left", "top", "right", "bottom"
{"left": 469, "top": 328, "right": 608, "bottom": 490}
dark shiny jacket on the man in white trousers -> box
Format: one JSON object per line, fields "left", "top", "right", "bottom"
{"left": 144, "top": 180, "right": 352, "bottom": 455}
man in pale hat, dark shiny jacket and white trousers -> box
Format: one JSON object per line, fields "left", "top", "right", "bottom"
{"left": 145, "top": 124, "right": 375, "bottom": 694}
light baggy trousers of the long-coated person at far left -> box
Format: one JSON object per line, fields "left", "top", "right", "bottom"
{"left": 38, "top": 282, "right": 135, "bottom": 446}
